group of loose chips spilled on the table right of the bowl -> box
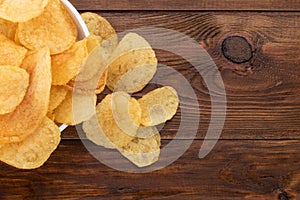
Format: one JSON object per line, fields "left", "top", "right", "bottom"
{"left": 79, "top": 13, "right": 179, "bottom": 167}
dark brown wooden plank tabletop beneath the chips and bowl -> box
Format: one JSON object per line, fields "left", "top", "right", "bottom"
{"left": 0, "top": 0, "right": 300, "bottom": 199}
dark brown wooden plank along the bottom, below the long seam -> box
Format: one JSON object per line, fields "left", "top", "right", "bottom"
{"left": 0, "top": 140, "right": 300, "bottom": 199}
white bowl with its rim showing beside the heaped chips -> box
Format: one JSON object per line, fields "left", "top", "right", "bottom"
{"left": 59, "top": 0, "right": 90, "bottom": 132}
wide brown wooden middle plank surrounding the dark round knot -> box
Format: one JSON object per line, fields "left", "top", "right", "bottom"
{"left": 64, "top": 12, "right": 300, "bottom": 139}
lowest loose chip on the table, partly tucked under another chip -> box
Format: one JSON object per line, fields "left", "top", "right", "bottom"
{"left": 118, "top": 134, "right": 160, "bottom": 167}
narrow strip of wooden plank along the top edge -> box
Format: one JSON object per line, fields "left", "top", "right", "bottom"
{"left": 70, "top": 0, "right": 300, "bottom": 11}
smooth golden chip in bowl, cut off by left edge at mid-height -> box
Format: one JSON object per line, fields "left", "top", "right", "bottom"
{"left": 0, "top": 66, "right": 29, "bottom": 114}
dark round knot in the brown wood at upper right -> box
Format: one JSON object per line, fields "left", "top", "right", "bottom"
{"left": 222, "top": 36, "right": 253, "bottom": 64}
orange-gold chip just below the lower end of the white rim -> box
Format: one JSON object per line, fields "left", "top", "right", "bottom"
{"left": 51, "top": 40, "right": 88, "bottom": 85}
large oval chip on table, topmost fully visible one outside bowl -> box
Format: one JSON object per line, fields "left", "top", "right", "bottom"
{"left": 107, "top": 34, "right": 157, "bottom": 93}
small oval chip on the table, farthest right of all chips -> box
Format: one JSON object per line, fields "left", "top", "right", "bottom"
{"left": 138, "top": 86, "right": 179, "bottom": 126}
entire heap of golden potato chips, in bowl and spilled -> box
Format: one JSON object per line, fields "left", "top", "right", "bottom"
{"left": 0, "top": 0, "right": 179, "bottom": 169}
